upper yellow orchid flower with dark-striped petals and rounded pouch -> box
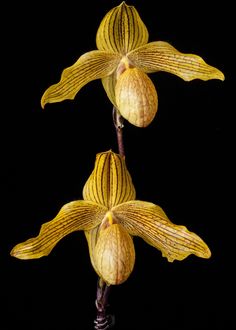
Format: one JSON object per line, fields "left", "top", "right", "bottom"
{"left": 41, "top": 2, "right": 224, "bottom": 127}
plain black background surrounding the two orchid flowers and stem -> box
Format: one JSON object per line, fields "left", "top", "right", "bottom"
{"left": 0, "top": 0, "right": 235, "bottom": 330}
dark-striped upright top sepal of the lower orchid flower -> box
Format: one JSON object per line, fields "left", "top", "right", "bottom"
{"left": 83, "top": 150, "right": 135, "bottom": 208}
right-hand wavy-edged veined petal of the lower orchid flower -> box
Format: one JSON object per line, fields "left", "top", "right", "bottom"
{"left": 112, "top": 201, "right": 211, "bottom": 261}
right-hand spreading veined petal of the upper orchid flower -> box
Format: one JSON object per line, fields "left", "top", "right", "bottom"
{"left": 127, "top": 41, "right": 224, "bottom": 81}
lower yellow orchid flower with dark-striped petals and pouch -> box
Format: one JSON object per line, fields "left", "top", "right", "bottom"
{"left": 11, "top": 150, "right": 211, "bottom": 285}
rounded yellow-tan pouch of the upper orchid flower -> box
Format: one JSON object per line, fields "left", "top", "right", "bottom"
{"left": 115, "top": 68, "right": 158, "bottom": 127}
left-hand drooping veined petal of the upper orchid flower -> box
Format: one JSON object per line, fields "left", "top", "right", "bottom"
{"left": 41, "top": 50, "right": 121, "bottom": 108}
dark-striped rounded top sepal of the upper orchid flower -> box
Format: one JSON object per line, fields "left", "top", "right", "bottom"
{"left": 96, "top": 1, "right": 148, "bottom": 55}
